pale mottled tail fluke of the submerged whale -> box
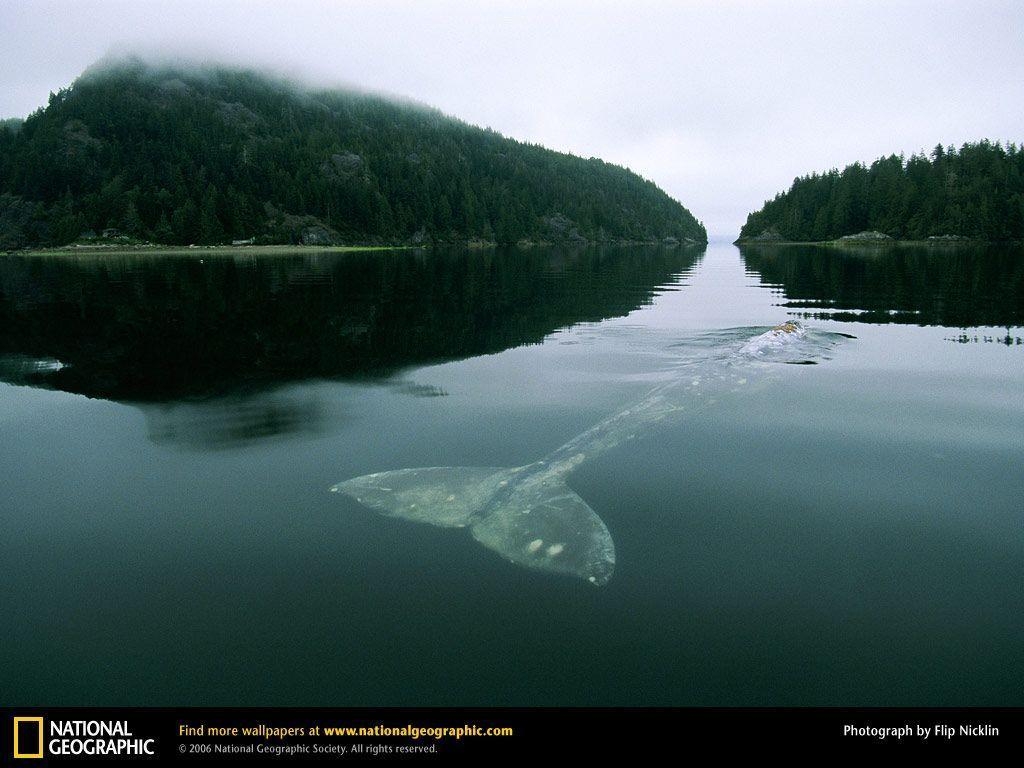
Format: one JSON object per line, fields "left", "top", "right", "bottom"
{"left": 331, "top": 467, "right": 615, "bottom": 586}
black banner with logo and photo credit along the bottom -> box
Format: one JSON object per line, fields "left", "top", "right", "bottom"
{"left": 0, "top": 708, "right": 1024, "bottom": 766}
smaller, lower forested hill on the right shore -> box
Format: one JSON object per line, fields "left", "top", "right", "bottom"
{"left": 739, "top": 141, "right": 1024, "bottom": 242}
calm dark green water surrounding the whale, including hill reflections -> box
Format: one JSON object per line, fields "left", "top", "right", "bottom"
{"left": 0, "top": 246, "right": 1024, "bottom": 706}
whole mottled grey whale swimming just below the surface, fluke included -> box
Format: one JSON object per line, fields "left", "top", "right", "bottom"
{"left": 331, "top": 322, "right": 851, "bottom": 586}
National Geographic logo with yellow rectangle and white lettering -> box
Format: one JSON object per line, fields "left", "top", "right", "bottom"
{"left": 14, "top": 717, "right": 157, "bottom": 759}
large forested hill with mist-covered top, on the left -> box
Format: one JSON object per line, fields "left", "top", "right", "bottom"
{"left": 0, "top": 59, "right": 707, "bottom": 250}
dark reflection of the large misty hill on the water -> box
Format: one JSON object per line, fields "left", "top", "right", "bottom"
{"left": 0, "top": 247, "right": 703, "bottom": 401}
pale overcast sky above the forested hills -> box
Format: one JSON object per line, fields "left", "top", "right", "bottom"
{"left": 0, "top": 0, "right": 1024, "bottom": 237}
